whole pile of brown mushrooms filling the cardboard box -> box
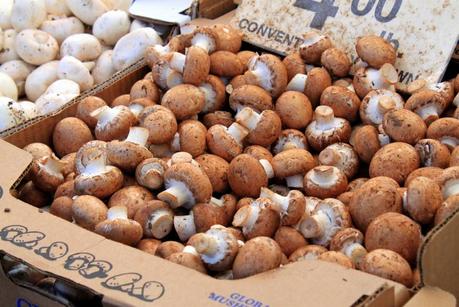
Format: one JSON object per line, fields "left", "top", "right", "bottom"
{"left": 20, "top": 25, "right": 459, "bottom": 287}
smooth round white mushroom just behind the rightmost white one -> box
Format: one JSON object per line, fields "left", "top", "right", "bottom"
{"left": 92, "top": 10, "right": 131, "bottom": 46}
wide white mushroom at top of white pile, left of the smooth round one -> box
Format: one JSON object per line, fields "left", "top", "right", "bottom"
{"left": 40, "top": 15, "right": 84, "bottom": 44}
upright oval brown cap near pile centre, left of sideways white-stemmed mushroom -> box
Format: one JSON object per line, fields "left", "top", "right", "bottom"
{"left": 178, "top": 119, "right": 207, "bottom": 157}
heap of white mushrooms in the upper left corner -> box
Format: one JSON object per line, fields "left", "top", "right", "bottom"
{"left": 0, "top": 0, "right": 162, "bottom": 131}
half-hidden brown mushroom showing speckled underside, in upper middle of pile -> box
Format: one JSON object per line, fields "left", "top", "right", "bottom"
{"left": 199, "top": 75, "right": 226, "bottom": 113}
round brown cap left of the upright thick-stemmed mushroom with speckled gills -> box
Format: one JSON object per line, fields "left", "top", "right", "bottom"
{"left": 276, "top": 91, "right": 313, "bottom": 129}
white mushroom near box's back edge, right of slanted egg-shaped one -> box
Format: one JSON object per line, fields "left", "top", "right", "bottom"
{"left": 57, "top": 56, "right": 94, "bottom": 91}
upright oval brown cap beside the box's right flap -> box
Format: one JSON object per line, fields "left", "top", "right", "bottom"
{"left": 404, "top": 177, "right": 443, "bottom": 224}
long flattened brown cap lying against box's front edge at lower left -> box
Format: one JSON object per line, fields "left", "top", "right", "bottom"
{"left": 94, "top": 218, "right": 142, "bottom": 246}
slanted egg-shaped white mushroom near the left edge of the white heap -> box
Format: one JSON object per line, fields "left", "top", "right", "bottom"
{"left": 25, "top": 61, "right": 59, "bottom": 101}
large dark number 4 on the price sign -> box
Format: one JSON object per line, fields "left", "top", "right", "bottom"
{"left": 293, "top": 0, "right": 338, "bottom": 30}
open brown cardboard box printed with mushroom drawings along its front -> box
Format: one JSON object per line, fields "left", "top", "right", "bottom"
{"left": 0, "top": 62, "right": 459, "bottom": 307}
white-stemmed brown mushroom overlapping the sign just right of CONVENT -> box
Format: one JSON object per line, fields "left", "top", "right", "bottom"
{"left": 299, "top": 31, "right": 333, "bottom": 64}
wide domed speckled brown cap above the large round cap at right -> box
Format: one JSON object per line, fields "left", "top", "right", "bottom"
{"left": 369, "top": 142, "right": 420, "bottom": 185}
